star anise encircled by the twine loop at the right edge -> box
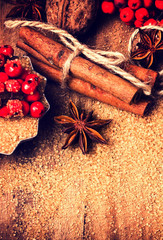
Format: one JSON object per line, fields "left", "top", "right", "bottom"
{"left": 131, "top": 29, "right": 163, "bottom": 68}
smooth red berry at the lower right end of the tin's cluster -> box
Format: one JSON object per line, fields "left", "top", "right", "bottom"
{"left": 30, "top": 101, "right": 45, "bottom": 118}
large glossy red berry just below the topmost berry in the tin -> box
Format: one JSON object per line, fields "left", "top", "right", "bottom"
{"left": 5, "top": 59, "right": 22, "bottom": 78}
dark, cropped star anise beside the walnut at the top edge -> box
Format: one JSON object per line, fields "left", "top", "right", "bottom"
{"left": 6, "top": 0, "right": 45, "bottom": 21}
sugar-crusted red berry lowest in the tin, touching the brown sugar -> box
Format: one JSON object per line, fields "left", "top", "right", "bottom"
{"left": 7, "top": 99, "right": 23, "bottom": 116}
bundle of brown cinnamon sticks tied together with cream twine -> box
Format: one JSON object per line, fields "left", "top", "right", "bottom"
{"left": 17, "top": 27, "right": 158, "bottom": 116}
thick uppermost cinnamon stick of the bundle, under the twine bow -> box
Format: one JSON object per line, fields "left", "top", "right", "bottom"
{"left": 19, "top": 27, "right": 142, "bottom": 104}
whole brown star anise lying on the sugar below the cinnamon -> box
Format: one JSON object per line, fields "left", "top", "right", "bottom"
{"left": 54, "top": 101, "right": 111, "bottom": 154}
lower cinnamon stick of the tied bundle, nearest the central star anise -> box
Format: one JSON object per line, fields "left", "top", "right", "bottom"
{"left": 27, "top": 53, "right": 151, "bottom": 116}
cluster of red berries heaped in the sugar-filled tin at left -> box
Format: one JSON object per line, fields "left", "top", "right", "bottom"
{"left": 0, "top": 45, "right": 45, "bottom": 118}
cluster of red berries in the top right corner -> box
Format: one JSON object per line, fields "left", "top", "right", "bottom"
{"left": 101, "top": 0, "right": 163, "bottom": 28}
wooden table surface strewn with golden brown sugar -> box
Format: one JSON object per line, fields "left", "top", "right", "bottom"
{"left": 0, "top": 1, "right": 163, "bottom": 240}
